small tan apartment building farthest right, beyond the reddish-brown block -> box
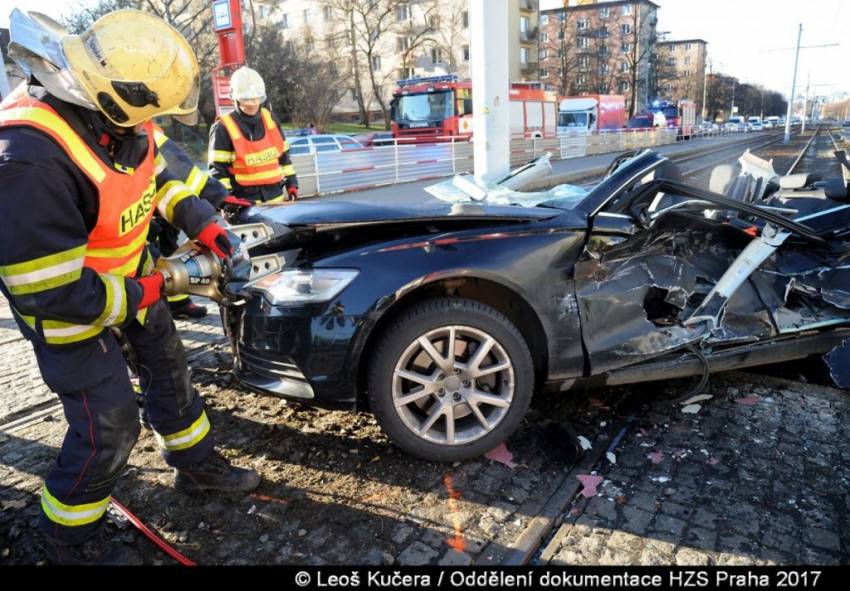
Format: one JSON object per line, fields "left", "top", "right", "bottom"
{"left": 656, "top": 39, "right": 708, "bottom": 113}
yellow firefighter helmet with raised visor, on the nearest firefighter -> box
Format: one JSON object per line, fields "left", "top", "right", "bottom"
{"left": 9, "top": 10, "right": 200, "bottom": 127}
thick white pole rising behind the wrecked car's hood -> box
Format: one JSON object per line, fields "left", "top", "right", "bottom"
{"left": 469, "top": 0, "right": 506, "bottom": 182}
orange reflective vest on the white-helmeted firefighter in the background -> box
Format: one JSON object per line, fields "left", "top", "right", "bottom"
{"left": 221, "top": 109, "right": 287, "bottom": 187}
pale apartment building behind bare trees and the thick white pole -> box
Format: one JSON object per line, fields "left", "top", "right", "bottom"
{"left": 255, "top": 0, "right": 539, "bottom": 114}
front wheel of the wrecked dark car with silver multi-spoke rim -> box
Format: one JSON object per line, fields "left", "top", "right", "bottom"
{"left": 368, "top": 297, "right": 534, "bottom": 462}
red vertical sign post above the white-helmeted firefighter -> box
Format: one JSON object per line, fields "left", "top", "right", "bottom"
{"left": 212, "top": 0, "right": 245, "bottom": 116}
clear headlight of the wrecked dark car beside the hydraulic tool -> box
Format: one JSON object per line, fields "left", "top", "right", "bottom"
{"left": 250, "top": 269, "right": 360, "bottom": 304}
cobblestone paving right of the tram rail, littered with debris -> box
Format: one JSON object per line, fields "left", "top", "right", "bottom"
{"left": 538, "top": 373, "right": 850, "bottom": 566}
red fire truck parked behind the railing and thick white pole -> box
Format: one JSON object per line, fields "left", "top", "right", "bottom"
{"left": 391, "top": 74, "right": 558, "bottom": 143}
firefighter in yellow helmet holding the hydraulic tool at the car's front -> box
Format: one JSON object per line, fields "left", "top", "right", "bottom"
{"left": 0, "top": 10, "right": 260, "bottom": 564}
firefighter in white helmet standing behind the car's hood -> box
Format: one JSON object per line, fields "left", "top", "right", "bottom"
{"left": 208, "top": 66, "right": 298, "bottom": 203}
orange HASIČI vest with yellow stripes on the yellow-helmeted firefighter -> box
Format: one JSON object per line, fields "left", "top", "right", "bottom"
{"left": 0, "top": 95, "right": 156, "bottom": 277}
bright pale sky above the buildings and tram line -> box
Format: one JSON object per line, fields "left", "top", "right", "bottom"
{"left": 6, "top": 0, "right": 850, "bottom": 99}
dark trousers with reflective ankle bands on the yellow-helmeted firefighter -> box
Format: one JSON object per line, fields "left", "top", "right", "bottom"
{"left": 34, "top": 300, "right": 213, "bottom": 544}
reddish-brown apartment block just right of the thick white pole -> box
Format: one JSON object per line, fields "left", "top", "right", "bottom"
{"left": 539, "top": 0, "right": 659, "bottom": 112}
